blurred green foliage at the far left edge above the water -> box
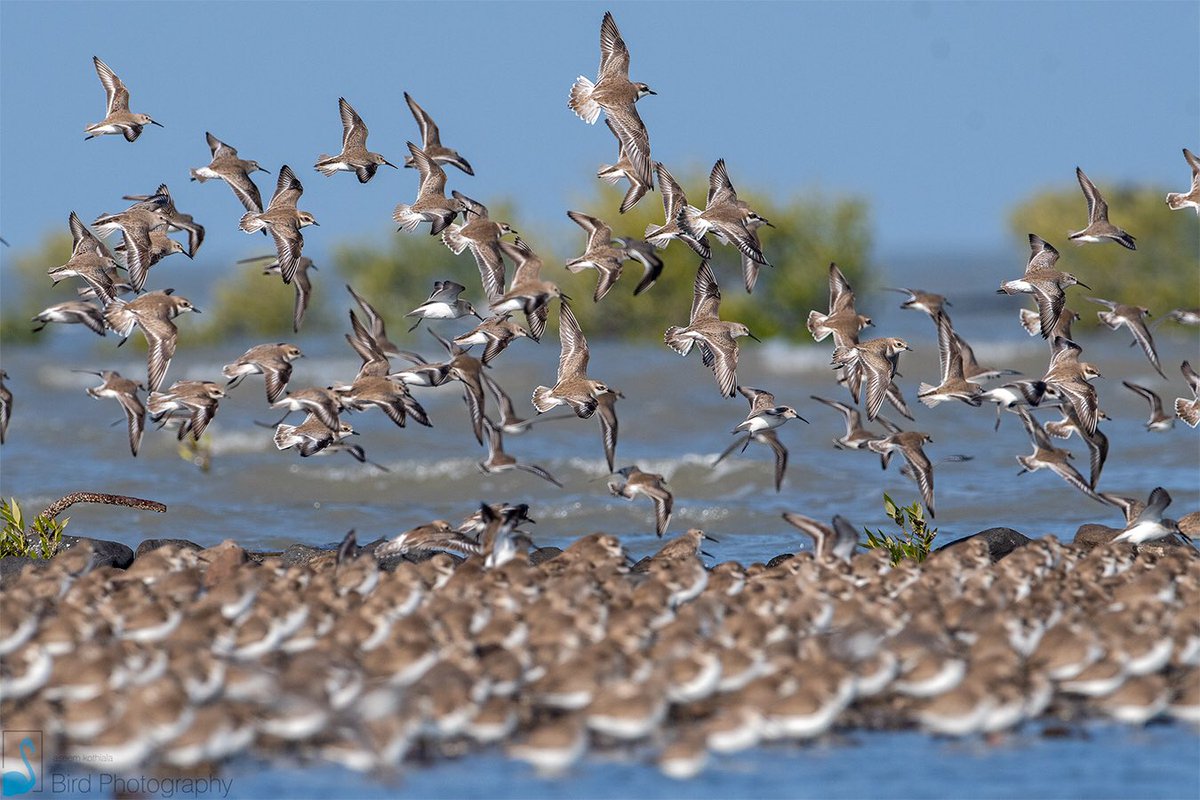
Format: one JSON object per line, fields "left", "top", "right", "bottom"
{"left": 0, "top": 231, "right": 75, "bottom": 344}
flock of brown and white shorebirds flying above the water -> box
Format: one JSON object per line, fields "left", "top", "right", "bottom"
{"left": 0, "top": 13, "right": 1200, "bottom": 551}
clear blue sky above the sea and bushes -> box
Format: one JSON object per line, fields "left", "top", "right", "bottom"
{"left": 0, "top": 0, "right": 1200, "bottom": 272}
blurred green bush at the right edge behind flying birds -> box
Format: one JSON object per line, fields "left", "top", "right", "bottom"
{"left": 1009, "top": 181, "right": 1200, "bottom": 325}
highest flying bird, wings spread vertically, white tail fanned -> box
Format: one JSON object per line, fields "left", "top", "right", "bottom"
{"left": 566, "top": 12, "right": 656, "bottom": 184}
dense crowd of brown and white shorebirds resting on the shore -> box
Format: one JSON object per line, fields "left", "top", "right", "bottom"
{"left": 0, "top": 525, "right": 1200, "bottom": 777}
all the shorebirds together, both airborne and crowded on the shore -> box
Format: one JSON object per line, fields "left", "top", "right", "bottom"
{"left": 0, "top": 13, "right": 1200, "bottom": 777}
